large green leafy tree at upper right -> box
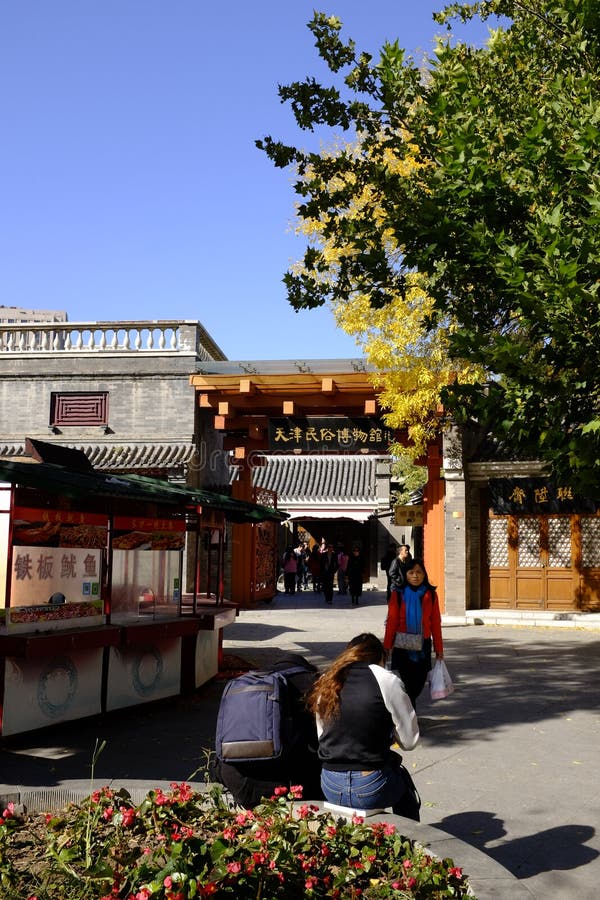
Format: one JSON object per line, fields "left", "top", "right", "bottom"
{"left": 258, "top": 0, "right": 600, "bottom": 493}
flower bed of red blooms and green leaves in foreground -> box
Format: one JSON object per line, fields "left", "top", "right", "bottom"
{"left": 0, "top": 784, "right": 469, "bottom": 900}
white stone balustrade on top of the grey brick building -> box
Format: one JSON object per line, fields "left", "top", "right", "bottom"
{"left": 0, "top": 319, "right": 226, "bottom": 361}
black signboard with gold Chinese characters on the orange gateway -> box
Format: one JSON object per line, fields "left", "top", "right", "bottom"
{"left": 269, "top": 416, "right": 394, "bottom": 453}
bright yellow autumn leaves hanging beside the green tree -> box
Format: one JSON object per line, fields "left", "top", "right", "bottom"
{"left": 292, "top": 136, "right": 481, "bottom": 461}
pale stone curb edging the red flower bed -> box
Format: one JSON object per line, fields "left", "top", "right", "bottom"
{"left": 0, "top": 780, "right": 531, "bottom": 900}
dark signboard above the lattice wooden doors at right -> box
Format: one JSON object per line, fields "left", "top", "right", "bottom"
{"left": 490, "top": 478, "right": 598, "bottom": 515}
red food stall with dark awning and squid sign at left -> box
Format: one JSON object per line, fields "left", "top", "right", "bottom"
{"left": 0, "top": 441, "right": 282, "bottom": 735}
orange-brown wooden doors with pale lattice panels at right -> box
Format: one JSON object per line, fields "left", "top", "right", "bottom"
{"left": 484, "top": 515, "right": 600, "bottom": 612}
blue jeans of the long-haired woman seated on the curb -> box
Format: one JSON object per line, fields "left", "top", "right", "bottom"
{"left": 321, "top": 766, "right": 406, "bottom": 809}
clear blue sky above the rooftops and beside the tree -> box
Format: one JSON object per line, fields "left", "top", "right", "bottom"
{"left": 0, "top": 0, "right": 496, "bottom": 359}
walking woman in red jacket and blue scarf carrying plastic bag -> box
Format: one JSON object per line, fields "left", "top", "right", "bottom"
{"left": 383, "top": 559, "right": 444, "bottom": 710}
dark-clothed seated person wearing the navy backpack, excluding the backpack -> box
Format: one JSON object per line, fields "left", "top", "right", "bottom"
{"left": 210, "top": 653, "right": 323, "bottom": 809}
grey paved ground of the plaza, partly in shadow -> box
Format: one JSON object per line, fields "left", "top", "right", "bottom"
{"left": 0, "top": 592, "right": 600, "bottom": 900}
